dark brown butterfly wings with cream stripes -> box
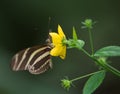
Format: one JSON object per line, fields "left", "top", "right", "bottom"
{"left": 11, "top": 45, "right": 52, "bottom": 74}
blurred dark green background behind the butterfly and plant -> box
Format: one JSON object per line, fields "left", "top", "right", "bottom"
{"left": 0, "top": 0, "right": 120, "bottom": 94}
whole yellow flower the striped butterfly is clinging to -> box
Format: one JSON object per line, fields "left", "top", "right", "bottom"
{"left": 49, "top": 25, "right": 66, "bottom": 59}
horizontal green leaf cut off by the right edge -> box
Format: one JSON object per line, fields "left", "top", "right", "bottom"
{"left": 94, "top": 46, "right": 120, "bottom": 56}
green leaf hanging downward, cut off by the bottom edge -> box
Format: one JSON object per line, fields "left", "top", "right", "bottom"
{"left": 83, "top": 70, "right": 105, "bottom": 94}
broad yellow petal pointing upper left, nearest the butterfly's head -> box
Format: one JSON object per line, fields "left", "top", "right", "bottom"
{"left": 49, "top": 33, "right": 61, "bottom": 46}
